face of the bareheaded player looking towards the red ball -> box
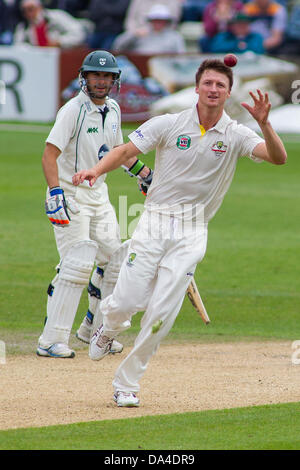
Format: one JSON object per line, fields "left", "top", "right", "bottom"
{"left": 196, "top": 69, "right": 230, "bottom": 108}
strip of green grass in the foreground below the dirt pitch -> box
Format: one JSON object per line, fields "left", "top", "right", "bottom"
{"left": 0, "top": 403, "right": 300, "bottom": 451}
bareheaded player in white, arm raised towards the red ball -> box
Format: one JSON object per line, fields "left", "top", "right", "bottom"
{"left": 73, "top": 59, "right": 287, "bottom": 407}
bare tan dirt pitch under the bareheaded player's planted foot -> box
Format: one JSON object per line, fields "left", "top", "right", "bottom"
{"left": 0, "top": 341, "right": 300, "bottom": 429}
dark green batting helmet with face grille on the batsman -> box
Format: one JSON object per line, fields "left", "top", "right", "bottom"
{"left": 79, "top": 51, "right": 121, "bottom": 94}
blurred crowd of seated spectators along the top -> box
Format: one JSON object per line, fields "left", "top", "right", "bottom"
{"left": 0, "top": 0, "right": 300, "bottom": 56}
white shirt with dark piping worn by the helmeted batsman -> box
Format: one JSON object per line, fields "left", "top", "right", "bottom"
{"left": 46, "top": 91, "right": 123, "bottom": 194}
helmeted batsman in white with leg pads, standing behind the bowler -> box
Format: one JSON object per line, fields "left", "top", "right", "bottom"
{"left": 37, "top": 50, "right": 152, "bottom": 358}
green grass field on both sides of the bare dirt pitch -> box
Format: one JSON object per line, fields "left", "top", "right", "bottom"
{"left": 0, "top": 125, "right": 300, "bottom": 450}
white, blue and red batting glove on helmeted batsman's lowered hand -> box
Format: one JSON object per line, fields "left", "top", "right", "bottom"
{"left": 45, "top": 186, "right": 79, "bottom": 227}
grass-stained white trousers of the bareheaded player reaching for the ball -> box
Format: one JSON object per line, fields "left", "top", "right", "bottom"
{"left": 100, "top": 210, "right": 207, "bottom": 392}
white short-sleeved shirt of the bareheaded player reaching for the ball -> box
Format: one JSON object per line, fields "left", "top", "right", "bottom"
{"left": 129, "top": 106, "right": 264, "bottom": 222}
